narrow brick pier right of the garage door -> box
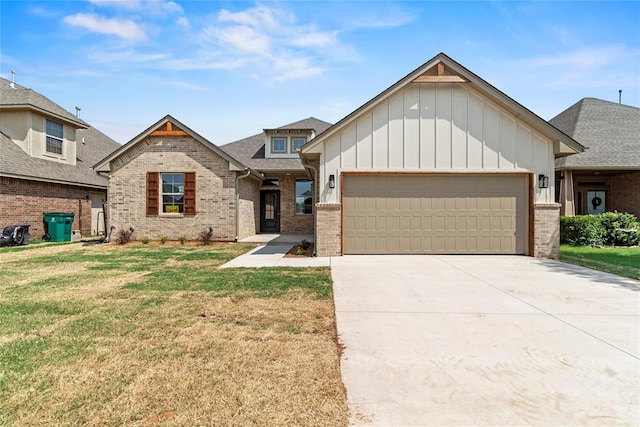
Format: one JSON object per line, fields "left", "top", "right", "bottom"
{"left": 533, "top": 203, "right": 560, "bottom": 259}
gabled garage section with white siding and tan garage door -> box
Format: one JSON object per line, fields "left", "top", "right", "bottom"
{"left": 301, "top": 53, "right": 583, "bottom": 257}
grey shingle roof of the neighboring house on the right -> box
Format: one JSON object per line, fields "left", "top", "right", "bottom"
{"left": 549, "top": 98, "right": 640, "bottom": 169}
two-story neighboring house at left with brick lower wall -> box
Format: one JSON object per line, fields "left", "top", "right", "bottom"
{"left": 0, "top": 78, "right": 120, "bottom": 237}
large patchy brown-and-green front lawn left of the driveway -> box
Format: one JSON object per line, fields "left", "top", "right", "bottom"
{"left": 0, "top": 243, "right": 348, "bottom": 426}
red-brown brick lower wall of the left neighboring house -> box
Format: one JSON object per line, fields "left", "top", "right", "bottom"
{"left": 0, "top": 177, "right": 101, "bottom": 238}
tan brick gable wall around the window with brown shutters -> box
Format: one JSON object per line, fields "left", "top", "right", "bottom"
{"left": 109, "top": 137, "right": 237, "bottom": 241}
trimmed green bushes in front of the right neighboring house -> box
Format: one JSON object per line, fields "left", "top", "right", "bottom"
{"left": 560, "top": 212, "right": 640, "bottom": 246}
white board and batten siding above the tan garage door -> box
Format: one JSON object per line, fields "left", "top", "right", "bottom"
{"left": 320, "top": 83, "right": 554, "bottom": 203}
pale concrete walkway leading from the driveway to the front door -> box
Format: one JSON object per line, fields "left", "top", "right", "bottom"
{"left": 219, "top": 234, "right": 331, "bottom": 268}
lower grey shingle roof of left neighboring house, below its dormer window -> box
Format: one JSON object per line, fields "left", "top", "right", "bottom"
{"left": 0, "top": 127, "right": 120, "bottom": 189}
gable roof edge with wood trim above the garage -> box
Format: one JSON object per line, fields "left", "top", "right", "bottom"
{"left": 301, "top": 53, "right": 584, "bottom": 157}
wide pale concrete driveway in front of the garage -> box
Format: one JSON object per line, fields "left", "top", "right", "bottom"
{"left": 331, "top": 255, "right": 640, "bottom": 426}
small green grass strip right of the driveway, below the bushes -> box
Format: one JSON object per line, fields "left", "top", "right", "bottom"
{"left": 560, "top": 245, "right": 640, "bottom": 280}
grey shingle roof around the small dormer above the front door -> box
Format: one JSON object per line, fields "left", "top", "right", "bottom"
{"left": 220, "top": 117, "right": 331, "bottom": 171}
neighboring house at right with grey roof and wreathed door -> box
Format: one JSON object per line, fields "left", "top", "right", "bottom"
{"left": 549, "top": 98, "right": 640, "bottom": 217}
